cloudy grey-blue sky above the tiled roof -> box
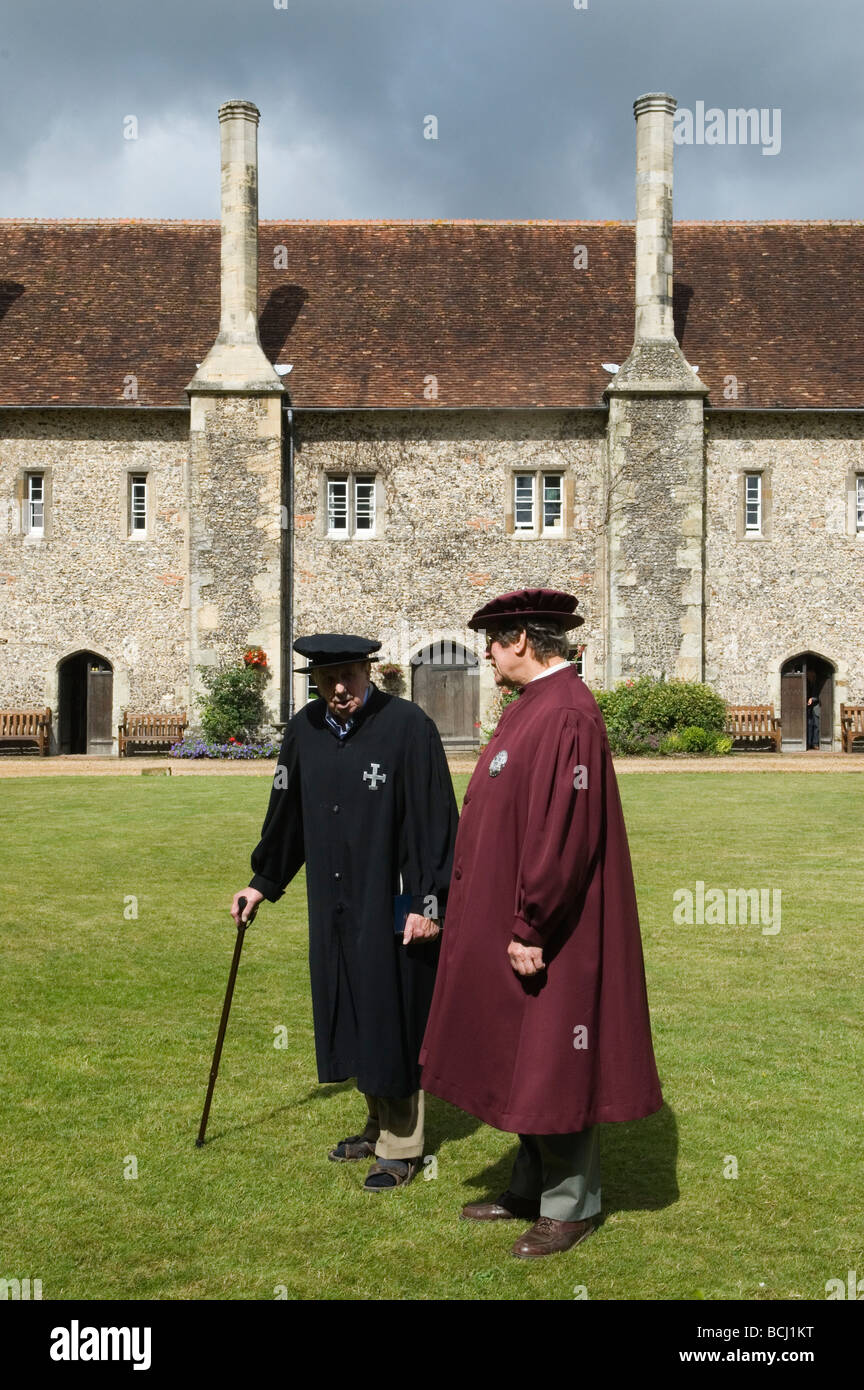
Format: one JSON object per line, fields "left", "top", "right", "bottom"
{"left": 0, "top": 0, "right": 864, "bottom": 221}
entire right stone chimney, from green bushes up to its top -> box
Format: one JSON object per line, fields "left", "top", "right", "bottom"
{"left": 606, "top": 92, "right": 707, "bottom": 685}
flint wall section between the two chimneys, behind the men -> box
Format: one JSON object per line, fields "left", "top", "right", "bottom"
{"left": 294, "top": 410, "right": 606, "bottom": 720}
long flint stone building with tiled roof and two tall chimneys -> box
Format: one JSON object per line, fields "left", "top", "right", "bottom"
{"left": 0, "top": 95, "right": 864, "bottom": 753}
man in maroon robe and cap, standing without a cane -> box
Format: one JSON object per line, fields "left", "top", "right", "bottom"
{"left": 421, "top": 589, "right": 663, "bottom": 1258}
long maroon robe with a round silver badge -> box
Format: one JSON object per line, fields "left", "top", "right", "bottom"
{"left": 419, "top": 667, "right": 663, "bottom": 1134}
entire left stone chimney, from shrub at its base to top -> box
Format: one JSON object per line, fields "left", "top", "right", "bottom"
{"left": 186, "top": 101, "right": 288, "bottom": 724}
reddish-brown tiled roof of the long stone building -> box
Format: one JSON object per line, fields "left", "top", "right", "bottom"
{"left": 0, "top": 218, "right": 864, "bottom": 410}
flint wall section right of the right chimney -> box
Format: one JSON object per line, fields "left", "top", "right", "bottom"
{"left": 706, "top": 411, "right": 864, "bottom": 733}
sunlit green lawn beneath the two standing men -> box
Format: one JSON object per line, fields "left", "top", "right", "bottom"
{"left": 0, "top": 773, "right": 864, "bottom": 1300}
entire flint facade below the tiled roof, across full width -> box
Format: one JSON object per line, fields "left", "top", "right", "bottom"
{"left": 0, "top": 396, "right": 864, "bottom": 756}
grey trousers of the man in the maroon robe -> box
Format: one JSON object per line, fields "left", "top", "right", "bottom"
{"left": 510, "top": 1125, "right": 600, "bottom": 1220}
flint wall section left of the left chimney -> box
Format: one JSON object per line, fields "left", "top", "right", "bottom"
{"left": 0, "top": 409, "right": 189, "bottom": 727}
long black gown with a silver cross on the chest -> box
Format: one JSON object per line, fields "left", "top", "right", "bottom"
{"left": 250, "top": 685, "right": 458, "bottom": 1098}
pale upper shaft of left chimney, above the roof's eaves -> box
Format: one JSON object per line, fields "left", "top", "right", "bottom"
{"left": 186, "top": 101, "right": 283, "bottom": 392}
